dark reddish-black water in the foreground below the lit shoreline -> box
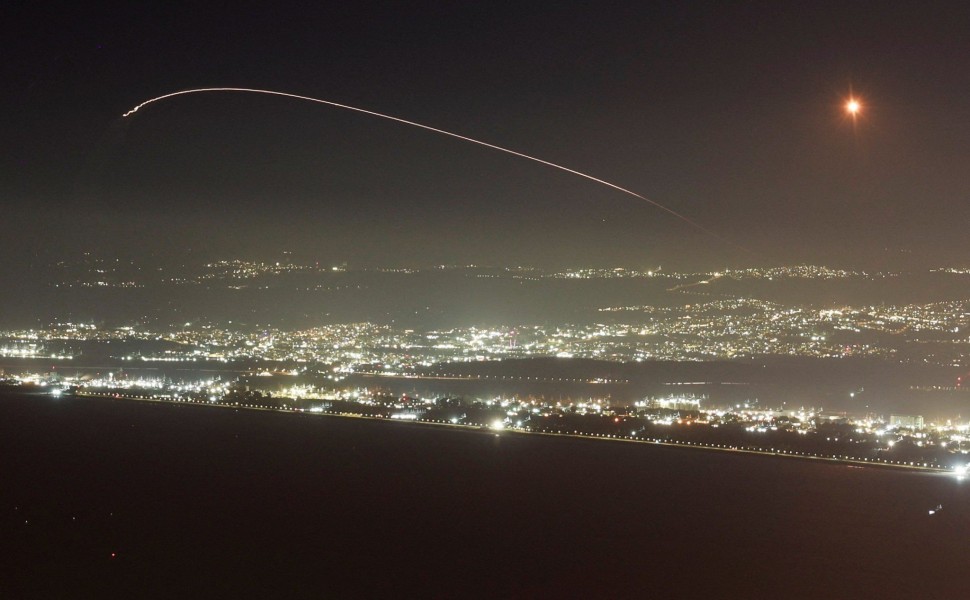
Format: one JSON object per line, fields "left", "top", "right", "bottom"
{"left": 0, "top": 395, "right": 970, "bottom": 599}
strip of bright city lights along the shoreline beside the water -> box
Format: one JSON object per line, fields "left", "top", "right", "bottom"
{"left": 4, "top": 372, "right": 970, "bottom": 477}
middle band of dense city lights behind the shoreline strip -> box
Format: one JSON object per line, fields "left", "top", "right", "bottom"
{"left": 0, "top": 288, "right": 970, "bottom": 369}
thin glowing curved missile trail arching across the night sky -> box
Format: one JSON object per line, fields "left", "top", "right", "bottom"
{"left": 122, "top": 87, "right": 736, "bottom": 252}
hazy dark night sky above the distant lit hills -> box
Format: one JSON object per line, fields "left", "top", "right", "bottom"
{"left": 0, "top": 0, "right": 970, "bottom": 267}
